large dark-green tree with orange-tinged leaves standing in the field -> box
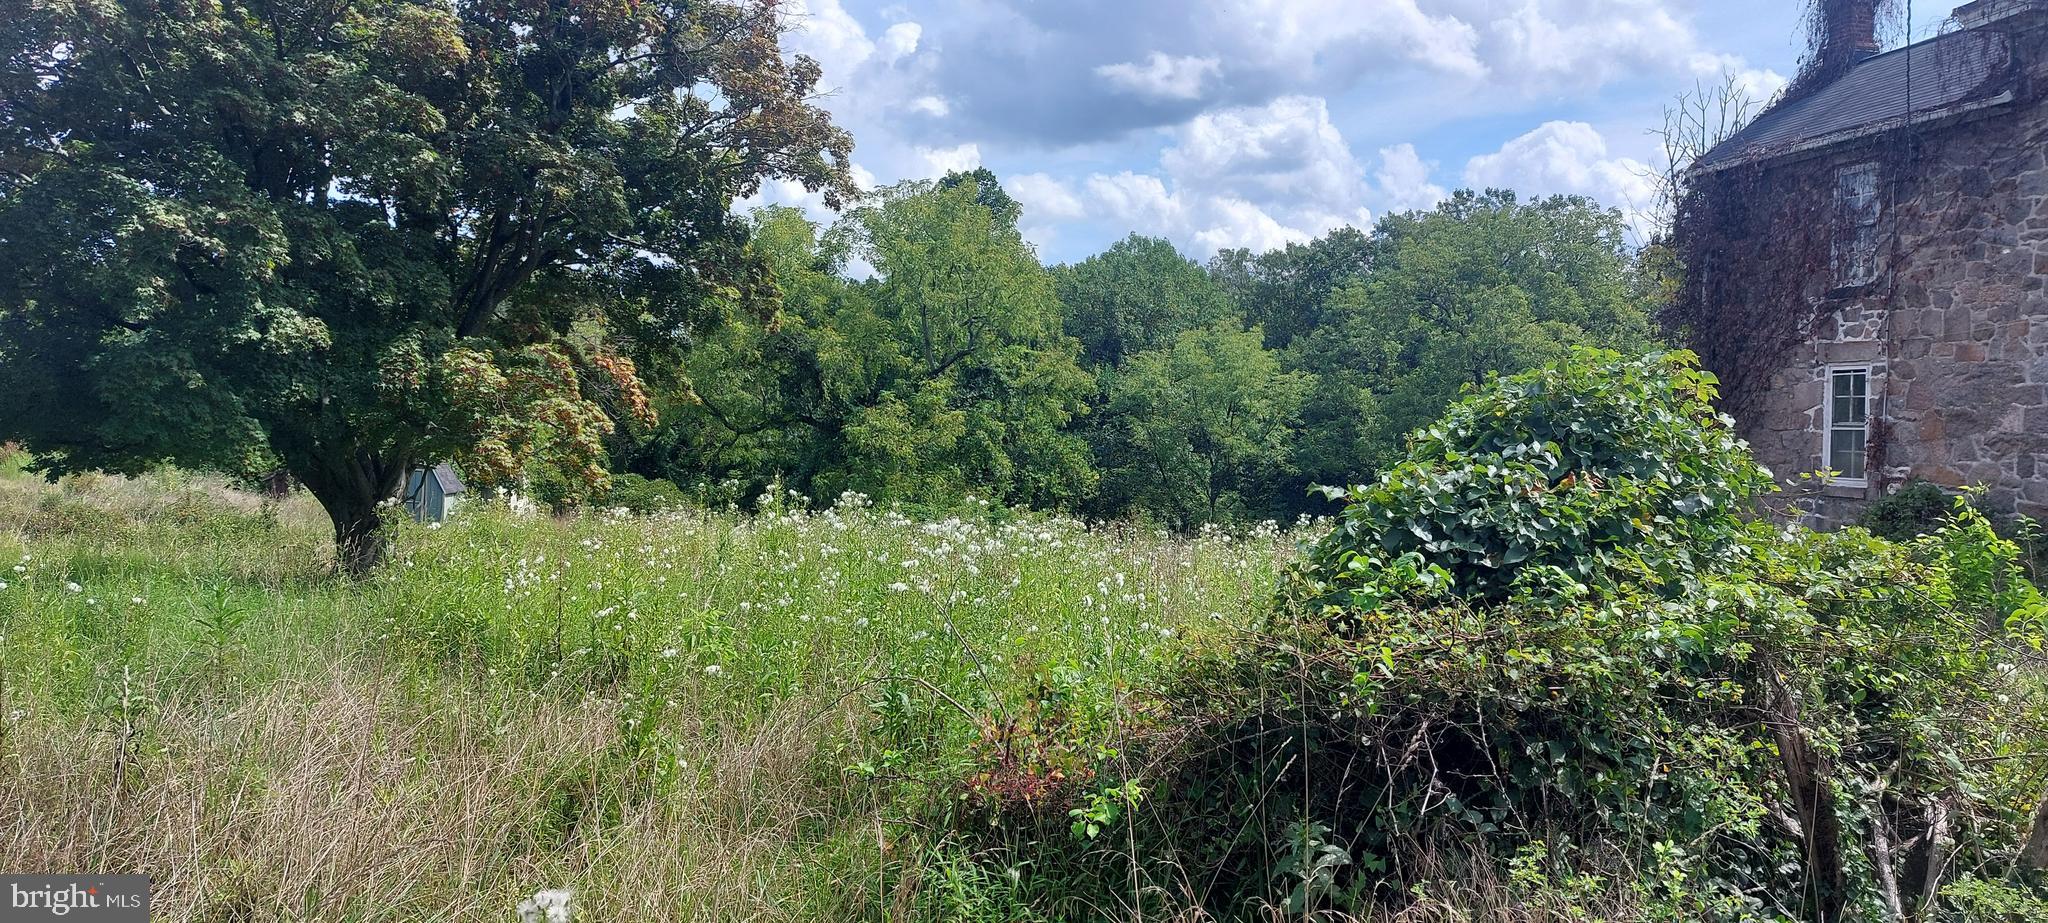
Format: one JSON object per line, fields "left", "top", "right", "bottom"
{"left": 0, "top": 0, "right": 850, "bottom": 571}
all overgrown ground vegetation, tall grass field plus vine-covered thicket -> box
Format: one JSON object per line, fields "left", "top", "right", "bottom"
{"left": 0, "top": 352, "right": 2048, "bottom": 923}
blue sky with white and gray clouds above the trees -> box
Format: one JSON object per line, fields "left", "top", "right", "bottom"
{"left": 741, "top": 0, "right": 1962, "bottom": 264}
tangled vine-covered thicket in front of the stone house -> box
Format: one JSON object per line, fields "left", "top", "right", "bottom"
{"left": 937, "top": 352, "right": 2048, "bottom": 921}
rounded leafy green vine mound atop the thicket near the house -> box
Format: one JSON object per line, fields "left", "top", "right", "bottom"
{"left": 1305, "top": 352, "right": 1772, "bottom": 612}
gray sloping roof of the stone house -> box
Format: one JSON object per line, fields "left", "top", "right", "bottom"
{"left": 1694, "top": 29, "right": 2013, "bottom": 170}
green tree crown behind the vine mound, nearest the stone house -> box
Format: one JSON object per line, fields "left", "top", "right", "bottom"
{"left": 1290, "top": 190, "right": 1653, "bottom": 476}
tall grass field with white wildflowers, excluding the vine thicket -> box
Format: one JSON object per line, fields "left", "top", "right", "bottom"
{"left": 0, "top": 465, "right": 1292, "bottom": 921}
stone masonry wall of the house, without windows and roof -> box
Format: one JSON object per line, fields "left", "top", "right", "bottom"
{"left": 1708, "top": 16, "right": 2048, "bottom": 524}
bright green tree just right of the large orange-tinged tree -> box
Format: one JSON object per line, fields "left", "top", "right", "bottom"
{"left": 657, "top": 174, "right": 1096, "bottom": 508}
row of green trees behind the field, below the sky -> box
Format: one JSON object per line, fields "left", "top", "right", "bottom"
{"left": 610, "top": 170, "right": 1663, "bottom": 528}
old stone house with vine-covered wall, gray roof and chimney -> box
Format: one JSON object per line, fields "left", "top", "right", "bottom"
{"left": 1673, "top": 0, "right": 2048, "bottom": 524}
